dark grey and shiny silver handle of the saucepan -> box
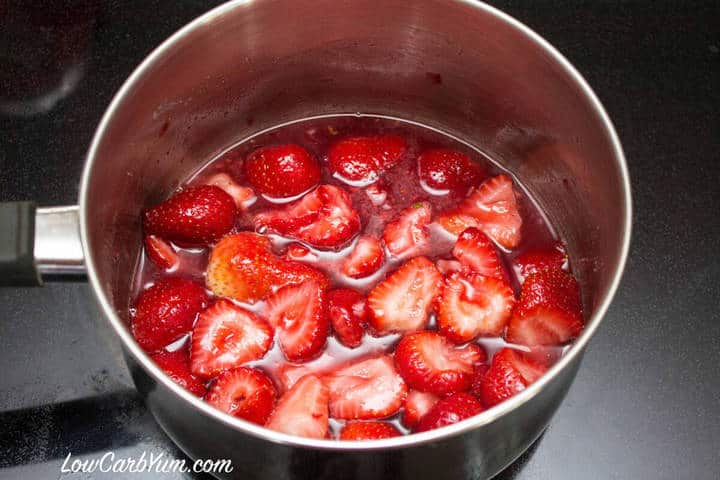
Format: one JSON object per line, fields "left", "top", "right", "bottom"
{"left": 0, "top": 202, "right": 85, "bottom": 286}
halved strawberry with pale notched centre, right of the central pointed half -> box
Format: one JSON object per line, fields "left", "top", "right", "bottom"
{"left": 437, "top": 273, "right": 515, "bottom": 344}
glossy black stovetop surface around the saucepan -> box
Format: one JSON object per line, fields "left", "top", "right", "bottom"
{"left": 0, "top": 0, "right": 720, "bottom": 479}
